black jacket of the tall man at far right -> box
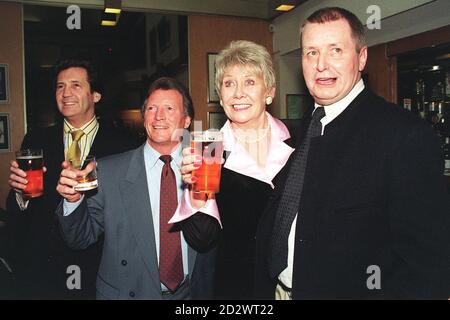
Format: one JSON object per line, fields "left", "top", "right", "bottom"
{"left": 255, "top": 89, "right": 450, "bottom": 299}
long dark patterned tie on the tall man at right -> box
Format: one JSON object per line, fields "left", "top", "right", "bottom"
{"left": 269, "top": 107, "right": 325, "bottom": 277}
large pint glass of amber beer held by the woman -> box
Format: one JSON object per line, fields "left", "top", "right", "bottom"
{"left": 191, "top": 130, "right": 223, "bottom": 194}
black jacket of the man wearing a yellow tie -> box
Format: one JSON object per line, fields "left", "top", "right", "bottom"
{"left": 7, "top": 123, "right": 136, "bottom": 299}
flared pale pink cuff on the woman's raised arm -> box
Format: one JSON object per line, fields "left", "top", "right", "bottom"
{"left": 169, "top": 188, "right": 222, "bottom": 228}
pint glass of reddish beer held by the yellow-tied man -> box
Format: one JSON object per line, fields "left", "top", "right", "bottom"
{"left": 16, "top": 149, "right": 44, "bottom": 199}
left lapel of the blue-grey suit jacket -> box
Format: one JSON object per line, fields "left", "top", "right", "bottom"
{"left": 120, "top": 146, "right": 160, "bottom": 287}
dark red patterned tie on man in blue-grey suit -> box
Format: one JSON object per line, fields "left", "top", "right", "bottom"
{"left": 159, "top": 155, "right": 183, "bottom": 292}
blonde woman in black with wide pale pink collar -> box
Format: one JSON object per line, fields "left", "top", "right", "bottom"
{"left": 173, "top": 40, "right": 300, "bottom": 299}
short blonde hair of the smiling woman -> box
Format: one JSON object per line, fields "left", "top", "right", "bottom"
{"left": 215, "top": 40, "right": 275, "bottom": 96}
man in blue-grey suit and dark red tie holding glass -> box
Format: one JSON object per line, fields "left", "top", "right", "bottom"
{"left": 57, "top": 78, "right": 213, "bottom": 300}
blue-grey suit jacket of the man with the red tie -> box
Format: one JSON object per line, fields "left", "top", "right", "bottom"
{"left": 57, "top": 146, "right": 214, "bottom": 299}
